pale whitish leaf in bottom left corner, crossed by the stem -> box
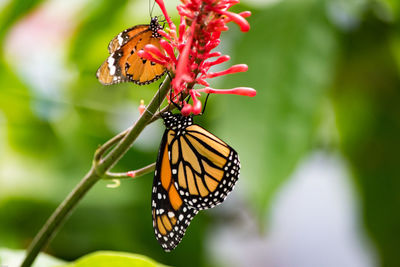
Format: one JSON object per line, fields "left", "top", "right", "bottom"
{"left": 0, "top": 248, "right": 65, "bottom": 267}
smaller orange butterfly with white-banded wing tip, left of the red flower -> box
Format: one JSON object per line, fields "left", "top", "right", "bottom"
{"left": 96, "top": 17, "right": 166, "bottom": 85}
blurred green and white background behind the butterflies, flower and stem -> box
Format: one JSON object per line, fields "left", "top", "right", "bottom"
{"left": 0, "top": 0, "right": 400, "bottom": 267}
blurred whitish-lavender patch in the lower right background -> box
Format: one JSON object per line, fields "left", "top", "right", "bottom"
{"left": 209, "top": 153, "right": 377, "bottom": 267}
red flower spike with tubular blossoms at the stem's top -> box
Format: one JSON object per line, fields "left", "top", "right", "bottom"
{"left": 139, "top": 0, "right": 256, "bottom": 116}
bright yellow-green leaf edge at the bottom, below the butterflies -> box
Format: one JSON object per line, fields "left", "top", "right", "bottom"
{"left": 59, "top": 251, "right": 165, "bottom": 267}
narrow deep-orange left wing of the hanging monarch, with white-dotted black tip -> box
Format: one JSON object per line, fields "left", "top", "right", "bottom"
{"left": 151, "top": 130, "right": 198, "bottom": 251}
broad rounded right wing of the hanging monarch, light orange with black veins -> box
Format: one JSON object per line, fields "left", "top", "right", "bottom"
{"left": 168, "top": 124, "right": 240, "bottom": 210}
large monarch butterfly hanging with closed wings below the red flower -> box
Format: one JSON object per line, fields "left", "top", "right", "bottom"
{"left": 152, "top": 112, "right": 240, "bottom": 251}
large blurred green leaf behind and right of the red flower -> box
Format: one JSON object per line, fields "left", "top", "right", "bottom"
{"left": 216, "top": 0, "right": 337, "bottom": 221}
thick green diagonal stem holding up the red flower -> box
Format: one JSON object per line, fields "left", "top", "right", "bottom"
{"left": 21, "top": 76, "right": 170, "bottom": 267}
